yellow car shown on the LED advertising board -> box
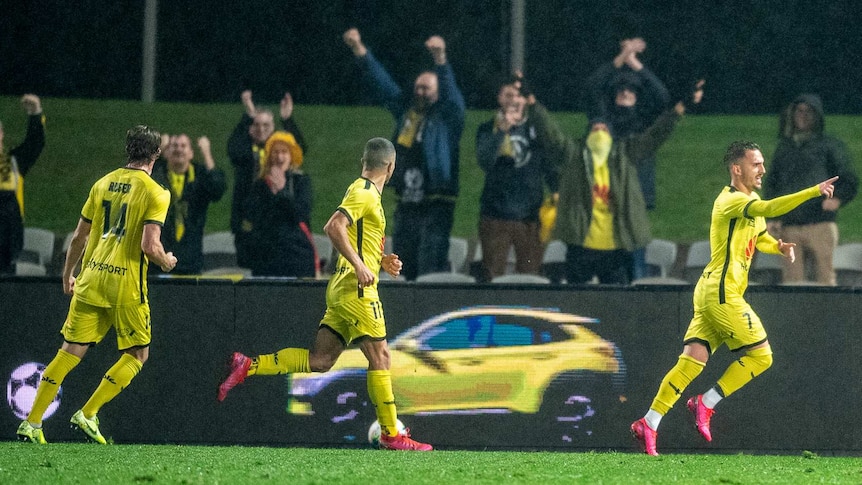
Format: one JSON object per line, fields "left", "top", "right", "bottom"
{"left": 287, "top": 306, "right": 625, "bottom": 442}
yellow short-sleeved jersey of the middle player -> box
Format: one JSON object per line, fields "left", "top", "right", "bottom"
{"left": 326, "top": 178, "right": 386, "bottom": 307}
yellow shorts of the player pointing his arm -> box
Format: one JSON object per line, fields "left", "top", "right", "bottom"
{"left": 683, "top": 299, "right": 766, "bottom": 353}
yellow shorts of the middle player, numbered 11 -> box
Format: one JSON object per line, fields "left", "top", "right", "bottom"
{"left": 320, "top": 298, "right": 386, "bottom": 345}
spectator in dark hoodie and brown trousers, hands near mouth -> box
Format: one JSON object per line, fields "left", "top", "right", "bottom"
{"left": 476, "top": 74, "right": 558, "bottom": 279}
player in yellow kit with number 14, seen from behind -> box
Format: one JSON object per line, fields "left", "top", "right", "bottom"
{"left": 18, "top": 125, "right": 177, "bottom": 444}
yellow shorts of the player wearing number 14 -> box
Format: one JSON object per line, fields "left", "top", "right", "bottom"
{"left": 60, "top": 297, "right": 152, "bottom": 350}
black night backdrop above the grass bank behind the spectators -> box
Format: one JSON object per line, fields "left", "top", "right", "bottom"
{"left": 0, "top": 0, "right": 862, "bottom": 114}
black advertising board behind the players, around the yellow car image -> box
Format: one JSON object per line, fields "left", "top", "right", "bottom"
{"left": 0, "top": 278, "right": 862, "bottom": 453}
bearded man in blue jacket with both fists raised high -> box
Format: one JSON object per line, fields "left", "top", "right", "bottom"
{"left": 344, "top": 29, "right": 465, "bottom": 280}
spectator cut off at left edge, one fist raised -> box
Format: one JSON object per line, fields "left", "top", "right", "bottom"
{"left": 0, "top": 94, "right": 45, "bottom": 274}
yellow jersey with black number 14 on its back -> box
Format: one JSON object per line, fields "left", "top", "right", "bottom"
{"left": 75, "top": 168, "right": 171, "bottom": 307}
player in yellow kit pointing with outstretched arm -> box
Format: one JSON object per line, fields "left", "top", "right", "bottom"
{"left": 631, "top": 141, "right": 838, "bottom": 455}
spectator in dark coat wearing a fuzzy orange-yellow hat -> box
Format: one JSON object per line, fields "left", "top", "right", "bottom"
{"left": 243, "top": 131, "right": 319, "bottom": 278}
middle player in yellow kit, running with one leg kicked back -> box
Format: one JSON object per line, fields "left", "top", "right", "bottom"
{"left": 218, "top": 138, "right": 432, "bottom": 451}
